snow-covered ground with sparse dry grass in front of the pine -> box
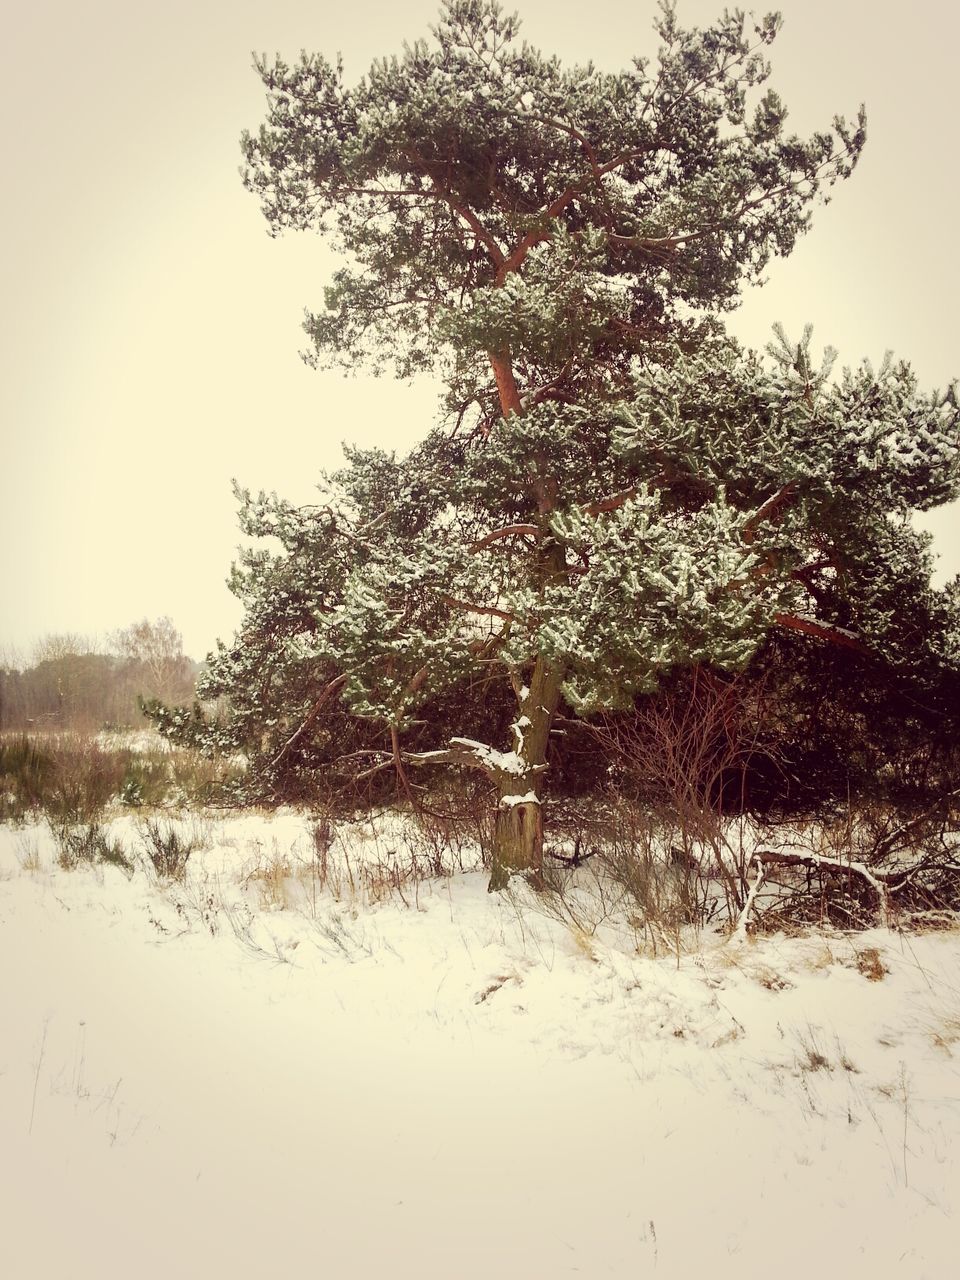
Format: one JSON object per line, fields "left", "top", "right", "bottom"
{"left": 0, "top": 814, "right": 960, "bottom": 1280}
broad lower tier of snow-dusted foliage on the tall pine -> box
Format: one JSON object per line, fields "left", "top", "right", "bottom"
{"left": 154, "top": 342, "right": 959, "bottom": 790}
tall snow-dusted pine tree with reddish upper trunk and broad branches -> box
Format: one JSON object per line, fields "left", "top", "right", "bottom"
{"left": 184, "top": 0, "right": 957, "bottom": 887}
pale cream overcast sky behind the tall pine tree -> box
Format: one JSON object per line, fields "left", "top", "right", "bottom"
{"left": 0, "top": 0, "right": 960, "bottom": 657}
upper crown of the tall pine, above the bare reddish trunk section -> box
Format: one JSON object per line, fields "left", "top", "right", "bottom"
{"left": 244, "top": 0, "right": 864, "bottom": 385}
